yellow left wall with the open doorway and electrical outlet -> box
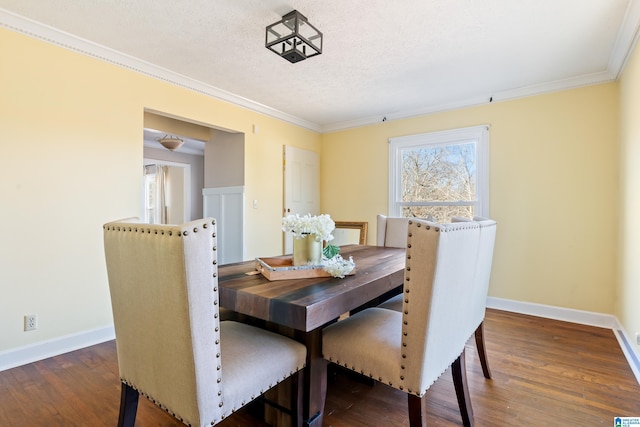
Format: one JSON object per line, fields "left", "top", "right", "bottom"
{"left": 0, "top": 29, "right": 320, "bottom": 352}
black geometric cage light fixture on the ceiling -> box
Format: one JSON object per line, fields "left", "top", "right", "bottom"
{"left": 265, "top": 10, "right": 322, "bottom": 63}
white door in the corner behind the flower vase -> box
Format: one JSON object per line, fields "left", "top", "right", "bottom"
{"left": 283, "top": 145, "right": 320, "bottom": 254}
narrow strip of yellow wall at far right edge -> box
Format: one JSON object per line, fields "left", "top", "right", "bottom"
{"left": 616, "top": 40, "right": 640, "bottom": 349}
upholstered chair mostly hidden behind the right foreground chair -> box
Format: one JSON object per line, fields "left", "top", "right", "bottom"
{"left": 378, "top": 216, "right": 496, "bottom": 379}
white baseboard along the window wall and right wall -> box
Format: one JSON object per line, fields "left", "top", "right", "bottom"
{"left": 487, "top": 297, "right": 640, "bottom": 384}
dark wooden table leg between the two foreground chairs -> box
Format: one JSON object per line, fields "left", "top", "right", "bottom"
{"left": 301, "top": 328, "right": 327, "bottom": 427}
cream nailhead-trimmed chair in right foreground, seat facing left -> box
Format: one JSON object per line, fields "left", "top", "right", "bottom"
{"left": 322, "top": 220, "right": 484, "bottom": 427}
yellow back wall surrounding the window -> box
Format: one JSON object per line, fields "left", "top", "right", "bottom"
{"left": 321, "top": 83, "right": 620, "bottom": 314}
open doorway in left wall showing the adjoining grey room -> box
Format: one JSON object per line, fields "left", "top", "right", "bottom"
{"left": 142, "top": 110, "right": 245, "bottom": 263}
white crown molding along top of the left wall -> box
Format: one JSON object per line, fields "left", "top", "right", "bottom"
{"left": 0, "top": 8, "right": 320, "bottom": 132}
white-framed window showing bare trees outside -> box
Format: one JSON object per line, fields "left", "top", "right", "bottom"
{"left": 389, "top": 126, "right": 489, "bottom": 222}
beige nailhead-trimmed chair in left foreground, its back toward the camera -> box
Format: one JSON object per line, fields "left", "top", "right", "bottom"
{"left": 104, "top": 218, "right": 306, "bottom": 426}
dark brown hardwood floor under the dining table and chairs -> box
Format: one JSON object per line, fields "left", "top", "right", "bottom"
{"left": 0, "top": 310, "right": 640, "bottom": 427}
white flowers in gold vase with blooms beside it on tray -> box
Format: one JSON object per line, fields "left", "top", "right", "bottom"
{"left": 282, "top": 214, "right": 355, "bottom": 278}
